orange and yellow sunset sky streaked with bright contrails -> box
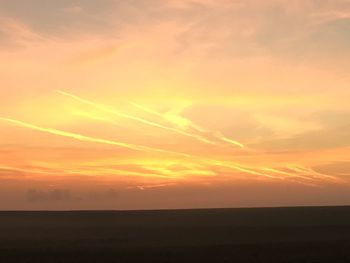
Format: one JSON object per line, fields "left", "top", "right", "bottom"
{"left": 0, "top": 0, "right": 350, "bottom": 210}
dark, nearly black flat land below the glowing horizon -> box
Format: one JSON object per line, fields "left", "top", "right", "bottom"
{"left": 0, "top": 207, "right": 350, "bottom": 263}
